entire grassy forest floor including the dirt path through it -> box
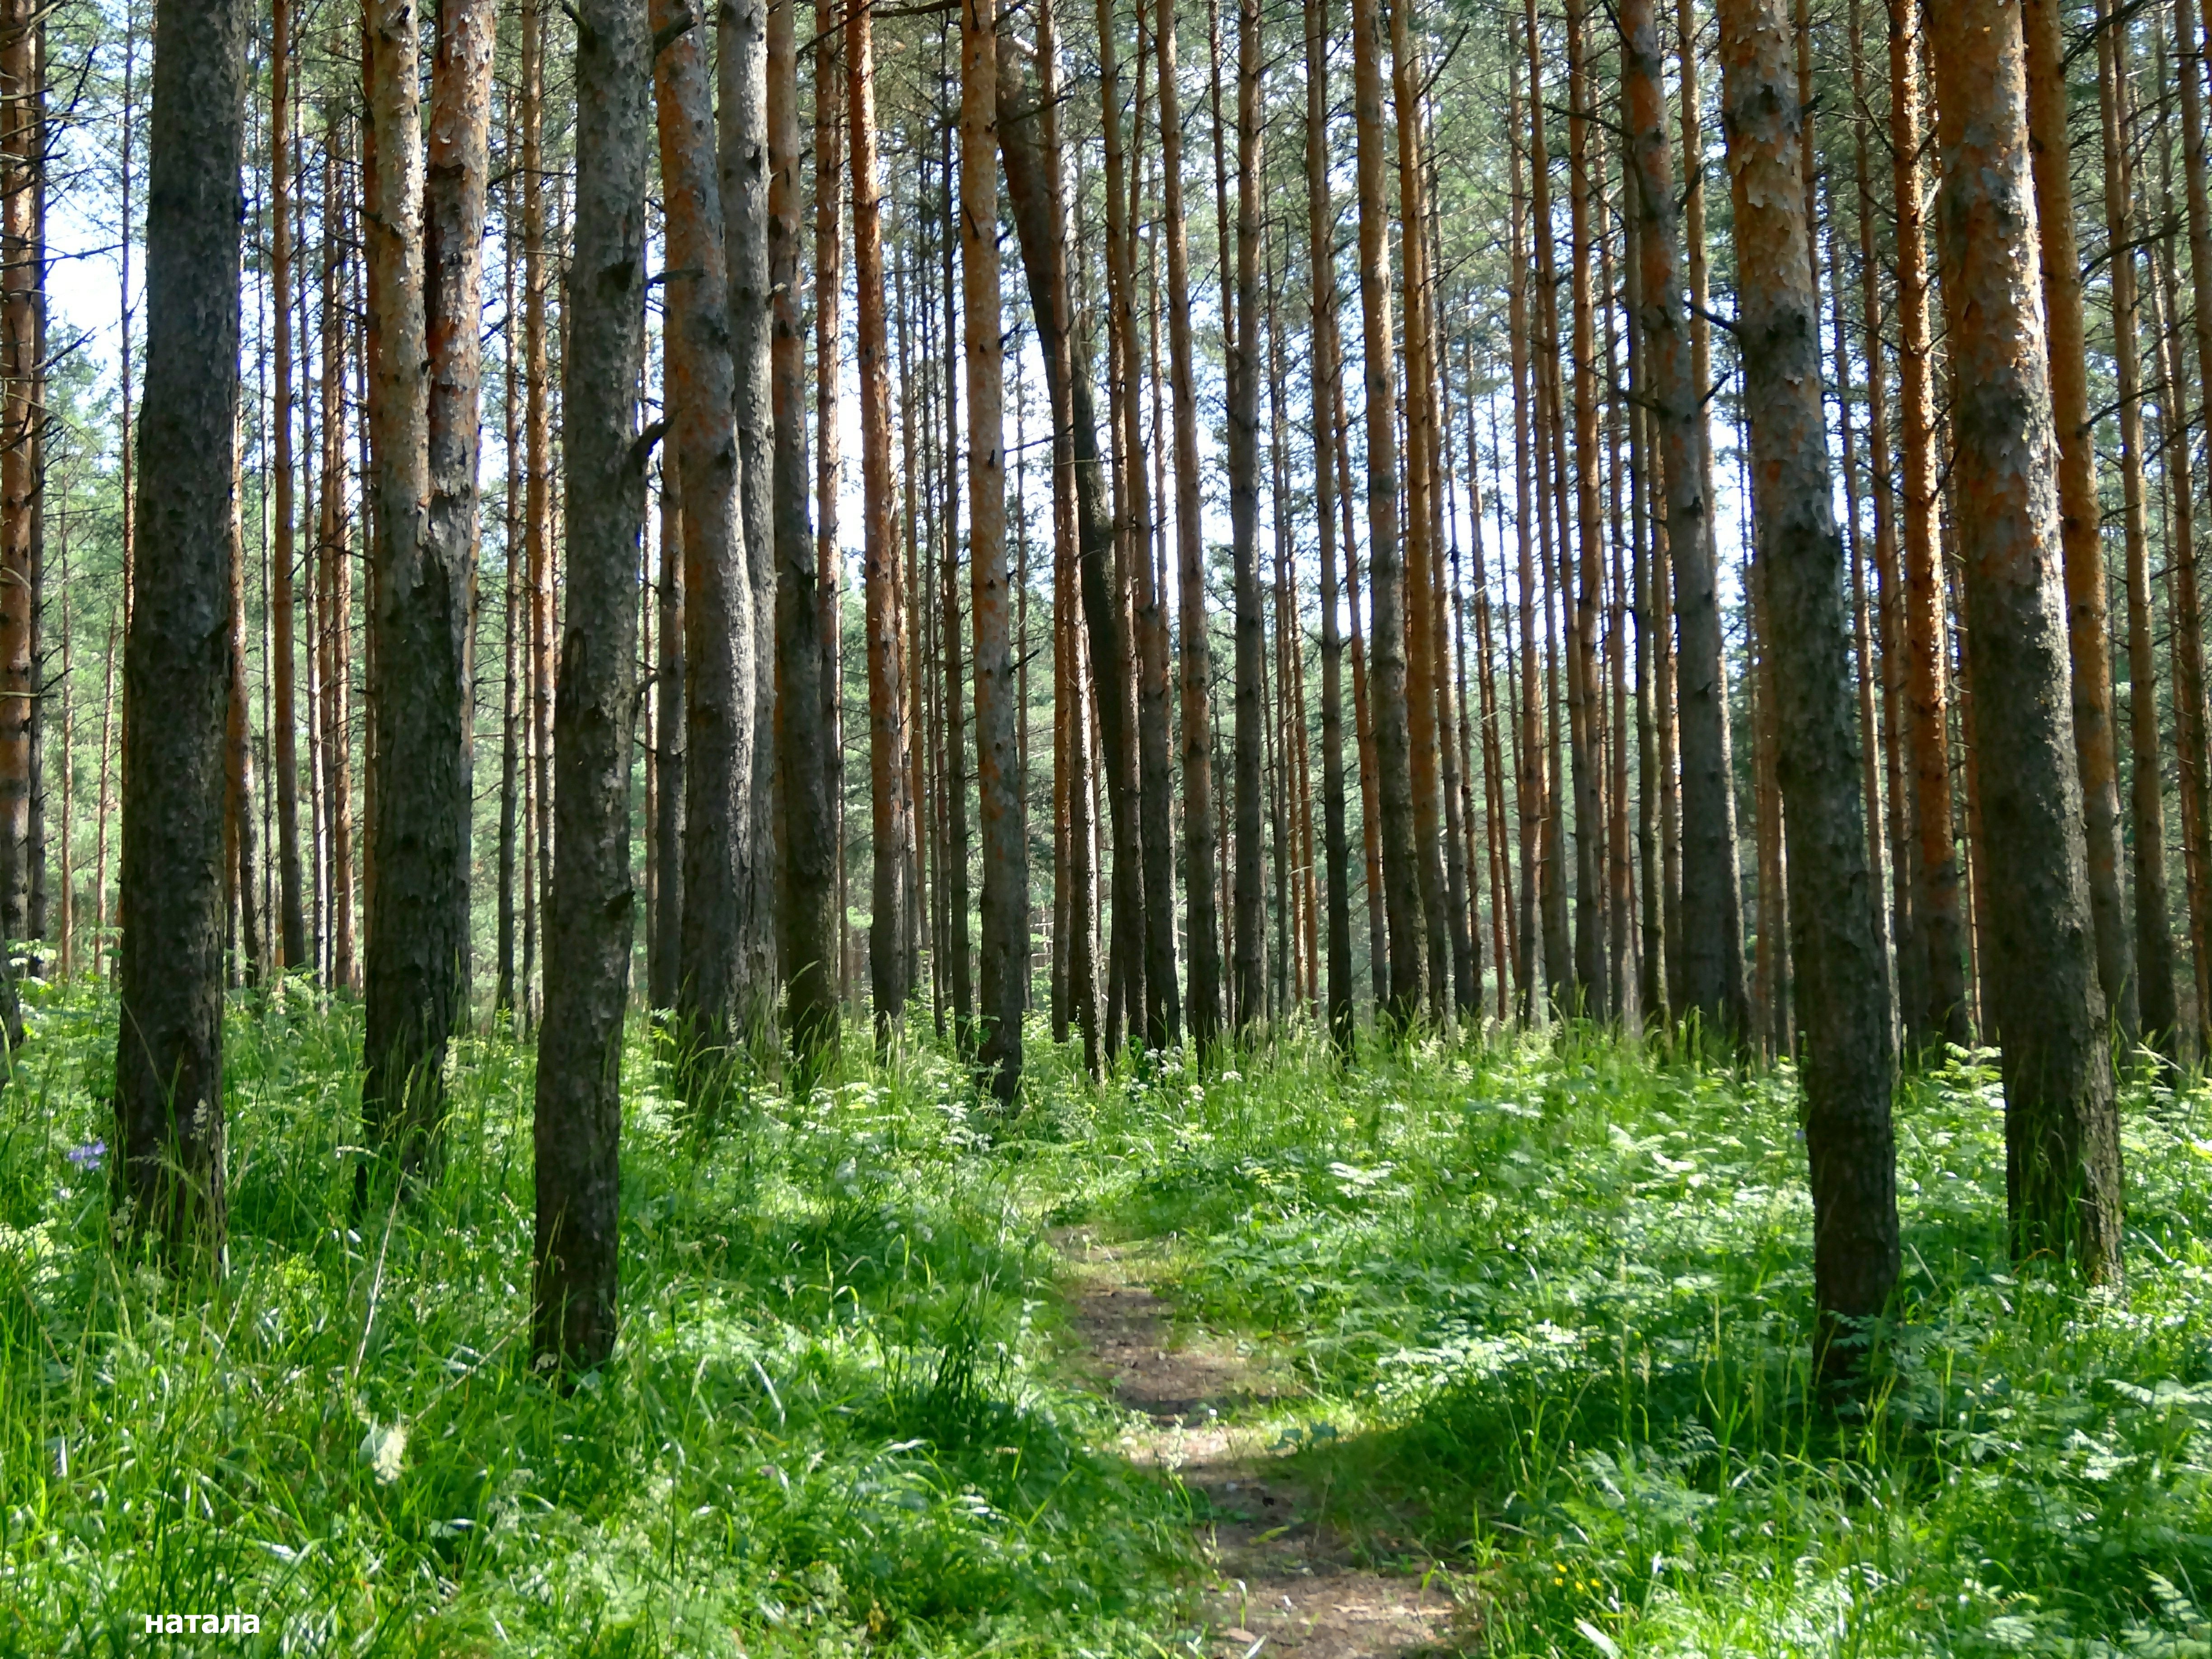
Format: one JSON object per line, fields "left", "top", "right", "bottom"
{"left": 0, "top": 987, "right": 2212, "bottom": 1659}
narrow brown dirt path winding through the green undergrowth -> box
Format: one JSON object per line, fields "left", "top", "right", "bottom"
{"left": 1055, "top": 1228, "right": 1462, "bottom": 1659}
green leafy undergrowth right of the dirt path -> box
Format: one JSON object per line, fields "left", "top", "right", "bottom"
{"left": 1040, "top": 1031, "right": 2212, "bottom": 1657}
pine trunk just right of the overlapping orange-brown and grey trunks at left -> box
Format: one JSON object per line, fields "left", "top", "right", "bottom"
{"left": 783, "top": 5, "right": 839, "bottom": 1093}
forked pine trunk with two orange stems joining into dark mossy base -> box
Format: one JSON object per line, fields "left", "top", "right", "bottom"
{"left": 358, "top": 0, "right": 475, "bottom": 1183}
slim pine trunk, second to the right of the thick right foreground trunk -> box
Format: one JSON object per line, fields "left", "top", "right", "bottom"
{"left": 2097, "top": 0, "right": 2179, "bottom": 1057}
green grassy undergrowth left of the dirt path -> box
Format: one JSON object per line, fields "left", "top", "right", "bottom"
{"left": 0, "top": 991, "right": 1190, "bottom": 1659}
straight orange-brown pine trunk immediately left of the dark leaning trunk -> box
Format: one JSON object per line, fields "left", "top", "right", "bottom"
{"left": 960, "top": 0, "right": 1029, "bottom": 1111}
